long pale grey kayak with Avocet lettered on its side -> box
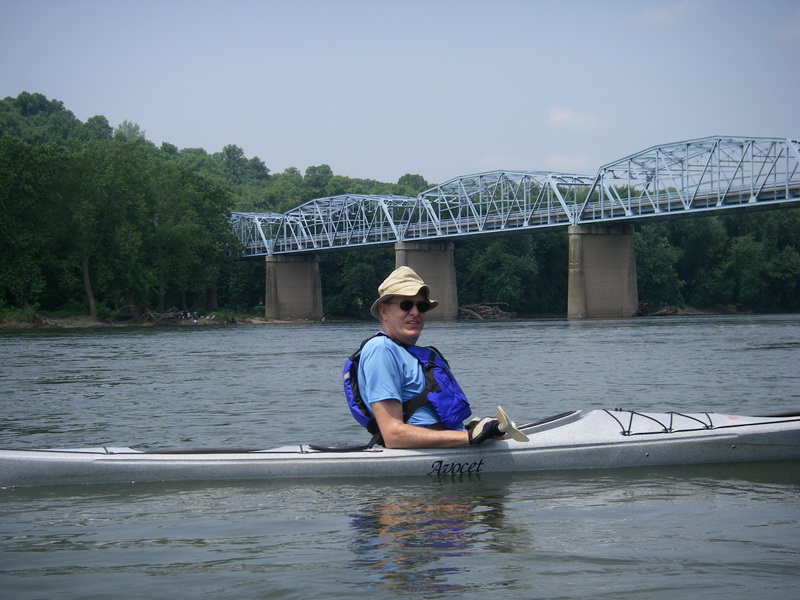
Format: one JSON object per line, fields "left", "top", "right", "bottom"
{"left": 0, "top": 410, "right": 800, "bottom": 488}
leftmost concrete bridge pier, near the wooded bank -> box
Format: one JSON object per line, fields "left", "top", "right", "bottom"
{"left": 264, "top": 254, "right": 323, "bottom": 321}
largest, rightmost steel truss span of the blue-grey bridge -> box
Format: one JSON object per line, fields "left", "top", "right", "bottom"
{"left": 576, "top": 137, "right": 800, "bottom": 223}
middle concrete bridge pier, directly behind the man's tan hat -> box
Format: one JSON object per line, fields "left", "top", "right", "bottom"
{"left": 394, "top": 242, "right": 458, "bottom": 321}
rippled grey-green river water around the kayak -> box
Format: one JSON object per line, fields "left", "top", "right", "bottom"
{"left": 0, "top": 315, "right": 800, "bottom": 600}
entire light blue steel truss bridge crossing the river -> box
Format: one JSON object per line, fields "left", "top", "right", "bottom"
{"left": 232, "top": 137, "right": 800, "bottom": 256}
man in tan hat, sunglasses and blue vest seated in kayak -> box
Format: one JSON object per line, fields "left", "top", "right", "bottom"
{"left": 351, "top": 267, "right": 503, "bottom": 448}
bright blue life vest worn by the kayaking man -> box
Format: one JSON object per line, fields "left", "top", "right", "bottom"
{"left": 342, "top": 332, "right": 472, "bottom": 439}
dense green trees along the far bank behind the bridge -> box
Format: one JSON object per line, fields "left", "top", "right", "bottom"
{"left": 0, "top": 92, "right": 800, "bottom": 318}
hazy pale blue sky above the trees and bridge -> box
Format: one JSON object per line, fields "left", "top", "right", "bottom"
{"left": 0, "top": 0, "right": 800, "bottom": 184}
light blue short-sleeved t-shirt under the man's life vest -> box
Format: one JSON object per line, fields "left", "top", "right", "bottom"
{"left": 358, "top": 335, "right": 440, "bottom": 426}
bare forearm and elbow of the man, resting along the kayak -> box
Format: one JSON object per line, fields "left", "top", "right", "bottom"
{"left": 370, "top": 400, "right": 469, "bottom": 448}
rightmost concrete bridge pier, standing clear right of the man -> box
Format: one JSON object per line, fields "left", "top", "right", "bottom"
{"left": 567, "top": 225, "right": 639, "bottom": 319}
